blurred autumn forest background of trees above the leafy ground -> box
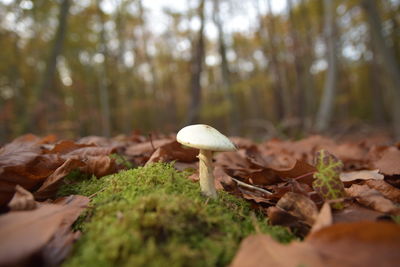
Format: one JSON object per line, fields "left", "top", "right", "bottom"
{"left": 0, "top": 0, "right": 400, "bottom": 143}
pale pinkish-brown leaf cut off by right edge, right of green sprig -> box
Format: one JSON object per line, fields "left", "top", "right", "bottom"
{"left": 374, "top": 147, "right": 400, "bottom": 175}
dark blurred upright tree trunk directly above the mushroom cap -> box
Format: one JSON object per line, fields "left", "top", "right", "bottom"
{"left": 187, "top": 0, "right": 205, "bottom": 124}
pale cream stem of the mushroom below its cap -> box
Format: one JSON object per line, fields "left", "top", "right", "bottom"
{"left": 197, "top": 149, "right": 217, "bottom": 198}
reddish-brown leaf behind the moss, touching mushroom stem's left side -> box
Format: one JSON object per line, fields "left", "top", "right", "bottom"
{"left": 146, "top": 141, "right": 199, "bottom": 164}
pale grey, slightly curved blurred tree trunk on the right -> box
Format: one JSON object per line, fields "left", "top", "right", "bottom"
{"left": 316, "top": 0, "right": 337, "bottom": 131}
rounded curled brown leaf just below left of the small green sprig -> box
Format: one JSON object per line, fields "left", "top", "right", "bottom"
{"left": 276, "top": 192, "right": 318, "bottom": 226}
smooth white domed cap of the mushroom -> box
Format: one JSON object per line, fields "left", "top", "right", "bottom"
{"left": 176, "top": 124, "right": 237, "bottom": 151}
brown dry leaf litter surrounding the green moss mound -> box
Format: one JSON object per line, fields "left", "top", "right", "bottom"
{"left": 0, "top": 133, "right": 400, "bottom": 266}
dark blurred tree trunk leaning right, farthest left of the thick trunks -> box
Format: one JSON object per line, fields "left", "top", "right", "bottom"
{"left": 33, "top": 0, "right": 71, "bottom": 130}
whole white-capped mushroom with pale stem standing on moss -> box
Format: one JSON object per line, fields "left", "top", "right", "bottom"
{"left": 176, "top": 124, "right": 237, "bottom": 198}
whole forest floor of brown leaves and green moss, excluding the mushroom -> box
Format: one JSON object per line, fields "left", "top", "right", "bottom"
{"left": 0, "top": 134, "right": 400, "bottom": 267}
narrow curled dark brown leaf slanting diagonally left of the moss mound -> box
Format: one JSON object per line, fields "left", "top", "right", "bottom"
{"left": 34, "top": 158, "right": 84, "bottom": 199}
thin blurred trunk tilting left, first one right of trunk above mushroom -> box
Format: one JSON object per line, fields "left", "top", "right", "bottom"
{"left": 213, "top": 0, "right": 240, "bottom": 135}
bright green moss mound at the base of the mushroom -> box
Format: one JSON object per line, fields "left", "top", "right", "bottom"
{"left": 60, "top": 164, "right": 293, "bottom": 266}
